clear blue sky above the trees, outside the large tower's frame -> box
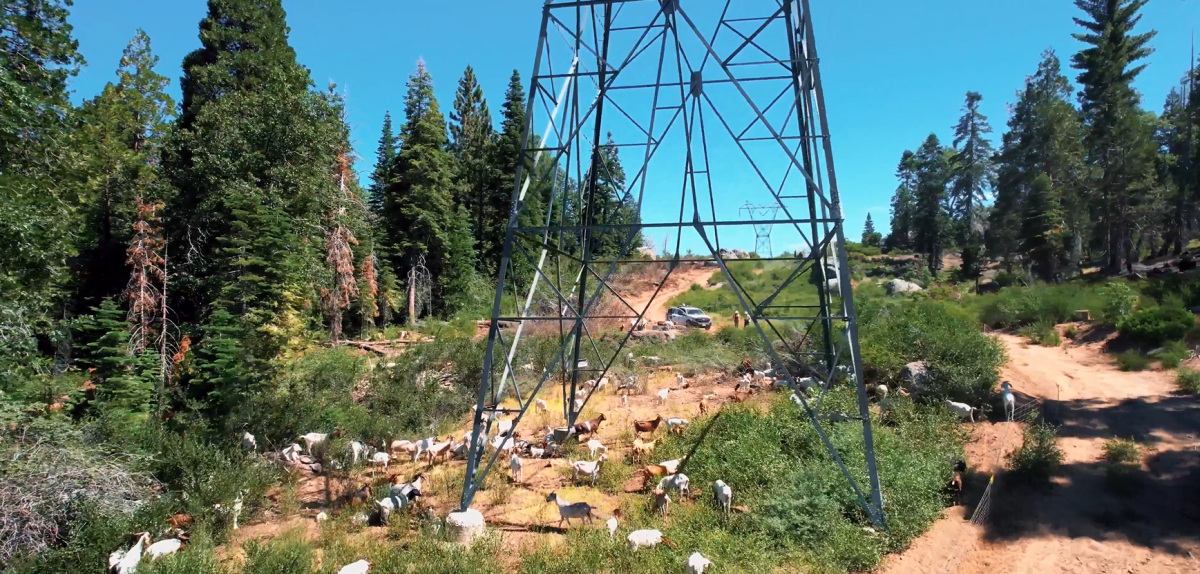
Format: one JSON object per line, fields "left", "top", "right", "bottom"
{"left": 71, "top": 0, "right": 1200, "bottom": 252}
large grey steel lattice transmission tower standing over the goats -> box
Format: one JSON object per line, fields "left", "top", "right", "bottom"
{"left": 461, "top": 0, "right": 883, "bottom": 526}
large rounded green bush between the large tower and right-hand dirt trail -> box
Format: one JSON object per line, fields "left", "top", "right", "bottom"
{"left": 859, "top": 297, "right": 1006, "bottom": 405}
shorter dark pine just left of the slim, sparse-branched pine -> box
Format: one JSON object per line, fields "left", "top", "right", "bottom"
{"left": 913, "top": 133, "right": 949, "bottom": 277}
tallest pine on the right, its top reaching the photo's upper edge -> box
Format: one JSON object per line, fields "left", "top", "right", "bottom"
{"left": 1072, "top": 0, "right": 1156, "bottom": 273}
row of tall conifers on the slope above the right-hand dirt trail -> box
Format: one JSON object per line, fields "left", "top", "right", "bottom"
{"left": 883, "top": 0, "right": 1200, "bottom": 281}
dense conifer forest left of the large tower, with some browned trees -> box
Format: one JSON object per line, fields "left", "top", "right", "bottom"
{"left": 0, "top": 0, "right": 640, "bottom": 415}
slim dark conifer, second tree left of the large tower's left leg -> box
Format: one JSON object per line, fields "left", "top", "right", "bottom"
{"left": 450, "top": 66, "right": 492, "bottom": 252}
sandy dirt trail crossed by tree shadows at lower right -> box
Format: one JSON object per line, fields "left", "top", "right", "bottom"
{"left": 881, "top": 326, "right": 1200, "bottom": 574}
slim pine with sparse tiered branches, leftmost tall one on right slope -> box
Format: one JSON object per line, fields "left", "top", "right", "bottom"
{"left": 950, "top": 91, "right": 996, "bottom": 280}
